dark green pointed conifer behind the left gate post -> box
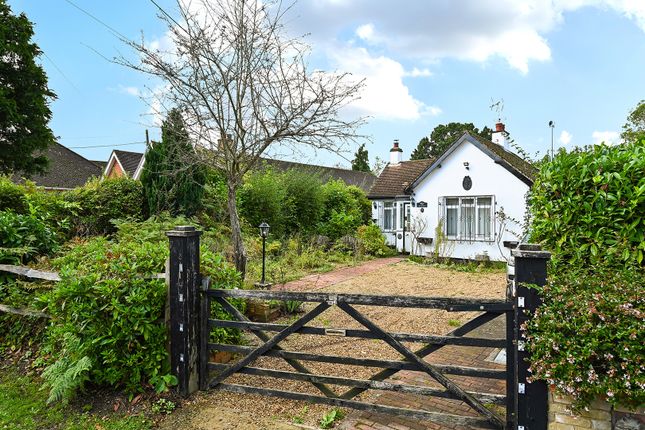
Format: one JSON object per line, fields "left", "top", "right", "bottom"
{"left": 141, "top": 109, "right": 206, "bottom": 216}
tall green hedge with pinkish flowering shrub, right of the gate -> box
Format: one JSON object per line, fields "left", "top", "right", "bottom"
{"left": 527, "top": 142, "right": 645, "bottom": 407}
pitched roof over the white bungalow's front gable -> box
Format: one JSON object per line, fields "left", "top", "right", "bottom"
{"left": 410, "top": 132, "right": 537, "bottom": 188}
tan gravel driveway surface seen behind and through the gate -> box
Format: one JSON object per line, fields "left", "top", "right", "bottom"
{"left": 162, "top": 261, "right": 505, "bottom": 429}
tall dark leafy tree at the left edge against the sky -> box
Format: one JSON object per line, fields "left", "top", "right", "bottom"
{"left": 0, "top": 0, "right": 56, "bottom": 175}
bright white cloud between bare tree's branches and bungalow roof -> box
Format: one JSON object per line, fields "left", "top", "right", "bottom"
{"left": 329, "top": 48, "right": 441, "bottom": 120}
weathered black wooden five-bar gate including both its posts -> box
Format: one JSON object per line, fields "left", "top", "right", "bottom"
{"left": 168, "top": 227, "right": 549, "bottom": 430}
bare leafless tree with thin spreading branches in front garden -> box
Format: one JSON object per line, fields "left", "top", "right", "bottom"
{"left": 117, "top": 0, "right": 364, "bottom": 273}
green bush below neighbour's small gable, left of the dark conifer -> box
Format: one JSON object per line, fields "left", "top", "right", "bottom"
{"left": 68, "top": 178, "right": 143, "bottom": 235}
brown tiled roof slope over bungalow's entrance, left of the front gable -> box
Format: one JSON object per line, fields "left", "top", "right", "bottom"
{"left": 367, "top": 159, "right": 434, "bottom": 199}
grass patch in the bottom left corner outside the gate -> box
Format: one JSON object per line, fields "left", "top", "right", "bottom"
{"left": 0, "top": 368, "right": 152, "bottom": 430}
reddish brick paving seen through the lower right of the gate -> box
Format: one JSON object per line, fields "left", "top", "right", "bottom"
{"left": 338, "top": 317, "right": 506, "bottom": 430}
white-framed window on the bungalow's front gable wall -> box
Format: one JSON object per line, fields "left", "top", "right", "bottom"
{"left": 442, "top": 196, "right": 494, "bottom": 240}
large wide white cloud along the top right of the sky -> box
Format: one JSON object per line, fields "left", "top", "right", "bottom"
{"left": 294, "top": 0, "right": 645, "bottom": 74}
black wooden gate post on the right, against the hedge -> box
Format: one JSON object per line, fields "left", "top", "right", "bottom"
{"left": 507, "top": 244, "right": 551, "bottom": 430}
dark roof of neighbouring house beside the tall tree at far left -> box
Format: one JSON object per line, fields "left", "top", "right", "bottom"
{"left": 14, "top": 143, "right": 102, "bottom": 190}
